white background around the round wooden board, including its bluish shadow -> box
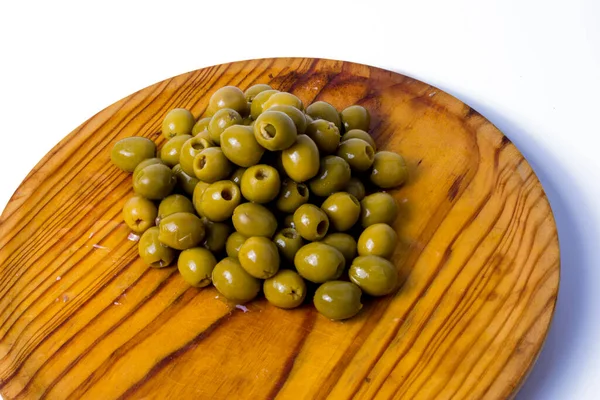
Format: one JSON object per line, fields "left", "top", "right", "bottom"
{"left": 0, "top": 0, "right": 600, "bottom": 400}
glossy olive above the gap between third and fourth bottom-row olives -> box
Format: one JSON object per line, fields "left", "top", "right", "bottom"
{"left": 238, "top": 236, "right": 280, "bottom": 279}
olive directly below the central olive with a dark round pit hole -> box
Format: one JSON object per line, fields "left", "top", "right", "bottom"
{"left": 231, "top": 203, "right": 277, "bottom": 238}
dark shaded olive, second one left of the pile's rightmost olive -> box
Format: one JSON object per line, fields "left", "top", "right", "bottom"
{"left": 309, "top": 156, "right": 352, "bottom": 197}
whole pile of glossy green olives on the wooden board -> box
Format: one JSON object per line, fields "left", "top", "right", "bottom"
{"left": 111, "top": 84, "right": 407, "bottom": 320}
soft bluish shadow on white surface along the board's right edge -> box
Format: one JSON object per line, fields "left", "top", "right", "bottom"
{"left": 448, "top": 95, "right": 588, "bottom": 400}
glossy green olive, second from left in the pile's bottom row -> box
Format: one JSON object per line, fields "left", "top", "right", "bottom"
{"left": 177, "top": 247, "right": 217, "bottom": 287}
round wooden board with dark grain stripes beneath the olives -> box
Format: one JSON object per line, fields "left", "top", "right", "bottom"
{"left": 0, "top": 58, "right": 559, "bottom": 399}
